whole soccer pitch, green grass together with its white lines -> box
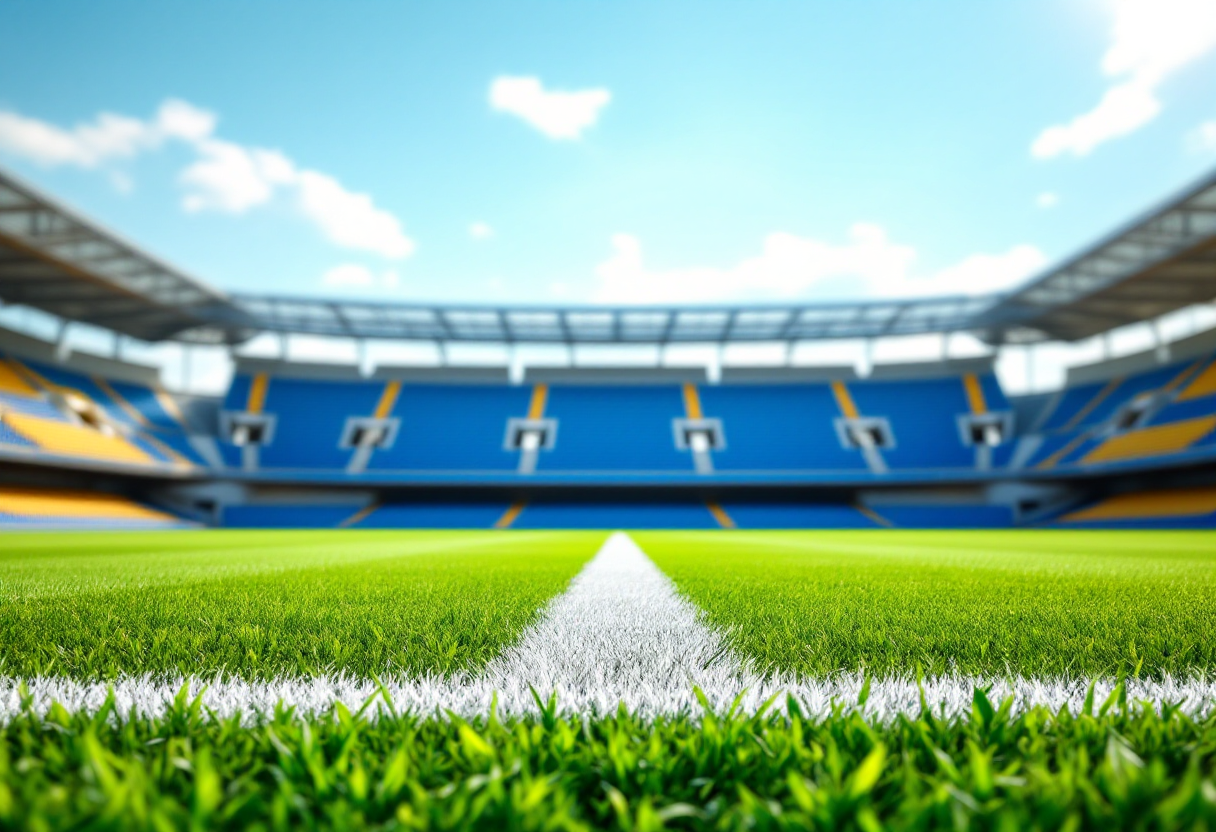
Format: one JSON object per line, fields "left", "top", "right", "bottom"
{"left": 0, "top": 532, "right": 1216, "bottom": 828}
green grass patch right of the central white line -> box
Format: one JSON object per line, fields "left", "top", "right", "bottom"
{"left": 634, "top": 532, "right": 1216, "bottom": 678}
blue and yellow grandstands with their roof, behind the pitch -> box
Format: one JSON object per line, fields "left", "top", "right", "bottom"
{"left": 0, "top": 165, "right": 1216, "bottom": 528}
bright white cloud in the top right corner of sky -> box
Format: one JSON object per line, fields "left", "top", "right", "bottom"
{"left": 1030, "top": 0, "right": 1216, "bottom": 158}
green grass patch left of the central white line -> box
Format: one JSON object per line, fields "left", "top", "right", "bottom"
{"left": 0, "top": 532, "right": 603, "bottom": 679}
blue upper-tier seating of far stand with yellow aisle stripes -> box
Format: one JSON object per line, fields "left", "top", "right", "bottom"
{"left": 221, "top": 373, "right": 1013, "bottom": 482}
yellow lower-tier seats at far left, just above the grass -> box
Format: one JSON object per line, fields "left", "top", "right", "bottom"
{"left": 0, "top": 487, "right": 190, "bottom": 529}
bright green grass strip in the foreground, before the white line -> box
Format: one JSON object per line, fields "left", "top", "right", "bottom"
{"left": 0, "top": 695, "right": 1216, "bottom": 832}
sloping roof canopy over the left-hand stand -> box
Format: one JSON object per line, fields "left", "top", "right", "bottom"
{"left": 0, "top": 172, "right": 254, "bottom": 343}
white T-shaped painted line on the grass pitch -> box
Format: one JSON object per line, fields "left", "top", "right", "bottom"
{"left": 0, "top": 533, "right": 1216, "bottom": 721}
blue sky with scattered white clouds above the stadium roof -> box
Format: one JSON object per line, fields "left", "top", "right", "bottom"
{"left": 0, "top": 0, "right": 1216, "bottom": 304}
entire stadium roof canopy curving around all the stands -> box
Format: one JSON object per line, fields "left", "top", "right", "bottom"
{"left": 0, "top": 164, "right": 1216, "bottom": 344}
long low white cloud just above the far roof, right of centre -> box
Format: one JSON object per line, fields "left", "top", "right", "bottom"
{"left": 593, "top": 223, "right": 1046, "bottom": 304}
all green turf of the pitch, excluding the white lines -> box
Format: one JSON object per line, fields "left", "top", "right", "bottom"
{"left": 0, "top": 532, "right": 1216, "bottom": 832}
